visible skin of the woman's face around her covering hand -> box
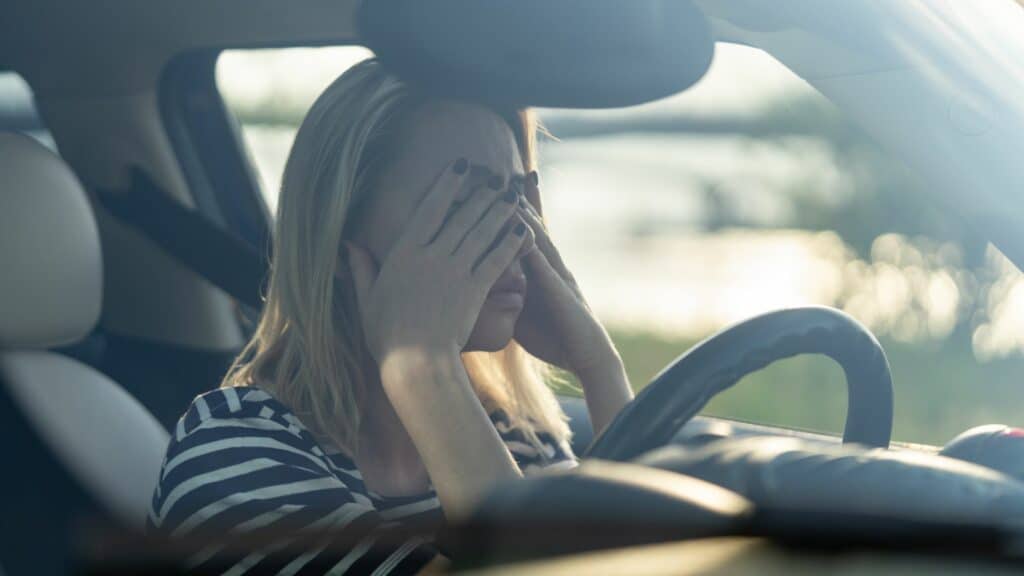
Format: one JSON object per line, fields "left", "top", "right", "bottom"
{"left": 352, "top": 101, "right": 526, "bottom": 352}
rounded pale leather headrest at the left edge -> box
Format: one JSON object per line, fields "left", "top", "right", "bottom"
{"left": 0, "top": 132, "right": 102, "bottom": 348}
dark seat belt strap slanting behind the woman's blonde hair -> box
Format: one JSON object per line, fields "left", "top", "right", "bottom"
{"left": 94, "top": 167, "right": 269, "bottom": 311}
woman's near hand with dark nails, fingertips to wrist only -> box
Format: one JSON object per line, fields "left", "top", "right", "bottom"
{"left": 347, "top": 159, "right": 531, "bottom": 365}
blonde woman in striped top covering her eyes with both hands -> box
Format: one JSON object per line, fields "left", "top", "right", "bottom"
{"left": 151, "top": 59, "right": 632, "bottom": 573}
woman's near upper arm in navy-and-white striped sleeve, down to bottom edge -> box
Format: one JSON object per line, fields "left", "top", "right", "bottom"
{"left": 148, "top": 387, "right": 439, "bottom": 574}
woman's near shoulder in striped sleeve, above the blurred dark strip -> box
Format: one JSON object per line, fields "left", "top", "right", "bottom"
{"left": 151, "top": 386, "right": 373, "bottom": 531}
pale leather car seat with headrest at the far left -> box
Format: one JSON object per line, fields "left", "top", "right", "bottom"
{"left": 0, "top": 132, "right": 168, "bottom": 538}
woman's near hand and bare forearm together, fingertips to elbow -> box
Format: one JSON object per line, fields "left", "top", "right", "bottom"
{"left": 347, "top": 160, "right": 531, "bottom": 520}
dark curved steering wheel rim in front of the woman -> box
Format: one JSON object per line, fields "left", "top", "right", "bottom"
{"left": 585, "top": 306, "right": 893, "bottom": 461}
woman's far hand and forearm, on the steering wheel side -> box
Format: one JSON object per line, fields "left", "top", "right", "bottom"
{"left": 515, "top": 172, "right": 633, "bottom": 434}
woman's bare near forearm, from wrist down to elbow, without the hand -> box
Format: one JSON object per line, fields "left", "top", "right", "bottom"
{"left": 381, "top": 347, "right": 521, "bottom": 520}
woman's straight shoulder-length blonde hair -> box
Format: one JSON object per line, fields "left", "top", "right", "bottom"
{"left": 222, "top": 58, "right": 569, "bottom": 454}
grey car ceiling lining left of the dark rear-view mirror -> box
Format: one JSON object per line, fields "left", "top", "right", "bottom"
{"left": 0, "top": 0, "right": 357, "bottom": 96}
